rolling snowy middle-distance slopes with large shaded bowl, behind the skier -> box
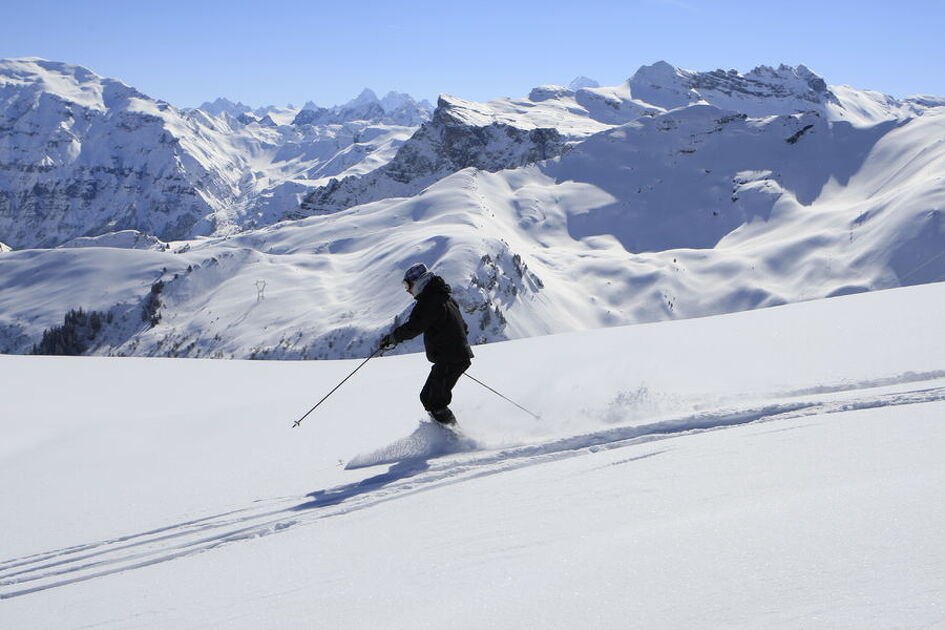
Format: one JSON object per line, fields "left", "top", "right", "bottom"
{"left": 0, "top": 100, "right": 945, "bottom": 358}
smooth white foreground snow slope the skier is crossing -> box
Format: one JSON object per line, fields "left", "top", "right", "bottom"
{"left": 0, "top": 286, "right": 945, "bottom": 628}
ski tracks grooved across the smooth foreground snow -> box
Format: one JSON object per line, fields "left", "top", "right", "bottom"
{"left": 0, "top": 371, "right": 945, "bottom": 599}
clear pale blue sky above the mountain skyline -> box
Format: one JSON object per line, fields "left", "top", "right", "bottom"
{"left": 0, "top": 0, "right": 945, "bottom": 106}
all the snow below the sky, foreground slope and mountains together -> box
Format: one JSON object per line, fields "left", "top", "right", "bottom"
{"left": 0, "top": 58, "right": 945, "bottom": 628}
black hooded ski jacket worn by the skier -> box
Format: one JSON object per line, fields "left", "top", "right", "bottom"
{"left": 393, "top": 276, "right": 473, "bottom": 363}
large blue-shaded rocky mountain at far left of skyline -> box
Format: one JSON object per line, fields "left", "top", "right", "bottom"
{"left": 0, "top": 59, "right": 219, "bottom": 248}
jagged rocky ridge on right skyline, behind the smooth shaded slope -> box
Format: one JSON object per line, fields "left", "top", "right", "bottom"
{"left": 302, "top": 61, "right": 935, "bottom": 220}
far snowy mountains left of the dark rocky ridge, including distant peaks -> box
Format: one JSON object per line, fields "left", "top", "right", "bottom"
{"left": 0, "top": 59, "right": 422, "bottom": 248}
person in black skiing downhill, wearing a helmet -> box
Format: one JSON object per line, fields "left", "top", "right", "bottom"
{"left": 380, "top": 263, "right": 474, "bottom": 425}
